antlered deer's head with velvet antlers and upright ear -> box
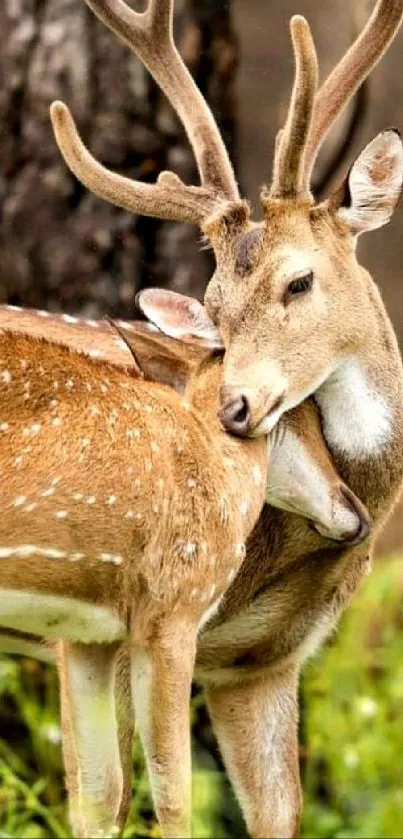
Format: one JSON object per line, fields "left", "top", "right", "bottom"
{"left": 51, "top": 0, "right": 403, "bottom": 435}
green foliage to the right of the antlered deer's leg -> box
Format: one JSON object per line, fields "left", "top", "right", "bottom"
{"left": 303, "top": 558, "right": 403, "bottom": 839}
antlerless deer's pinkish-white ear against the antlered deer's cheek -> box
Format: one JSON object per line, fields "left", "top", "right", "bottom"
{"left": 136, "top": 288, "right": 224, "bottom": 349}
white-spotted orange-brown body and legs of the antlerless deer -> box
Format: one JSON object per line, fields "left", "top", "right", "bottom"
{"left": 0, "top": 332, "right": 267, "bottom": 836}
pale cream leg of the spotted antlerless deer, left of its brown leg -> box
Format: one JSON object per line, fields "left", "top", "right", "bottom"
{"left": 59, "top": 642, "right": 123, "bottom": 839}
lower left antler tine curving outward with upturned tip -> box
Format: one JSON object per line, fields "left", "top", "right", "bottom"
{"left": 50, "top": 102, "right": 219, "bottom": 225}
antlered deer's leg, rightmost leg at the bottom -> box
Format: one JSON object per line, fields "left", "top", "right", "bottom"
{"left": 207, "top": 671, "right": 301, "bottom": 839}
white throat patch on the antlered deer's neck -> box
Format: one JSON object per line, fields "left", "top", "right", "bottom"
{"left": 316, "top": 359, "right": 392, "bottom": 459}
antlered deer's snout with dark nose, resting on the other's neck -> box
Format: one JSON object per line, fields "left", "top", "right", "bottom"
{"left": 219, "top": 385, "right": 285, "bottom": 437}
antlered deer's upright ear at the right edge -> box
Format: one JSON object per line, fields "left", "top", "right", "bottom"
{"left": 330, "top": 129, "right": 403, "bottom": 235}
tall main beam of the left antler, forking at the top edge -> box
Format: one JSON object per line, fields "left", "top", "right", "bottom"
{"left": 85, "top": 0, "right": 239, "bottom": 200}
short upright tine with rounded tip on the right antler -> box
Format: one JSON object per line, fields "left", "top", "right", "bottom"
{"left": 270, "top": 15, "right": 318, "bottom": 198}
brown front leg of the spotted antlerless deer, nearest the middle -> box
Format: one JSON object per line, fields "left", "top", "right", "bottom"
{"left": 132, "top": 624, "right": 196, "bottom": 839}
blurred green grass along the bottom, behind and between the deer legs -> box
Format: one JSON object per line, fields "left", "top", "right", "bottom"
{"left": 0, "top": 558, "right": 403, "bottom": 839}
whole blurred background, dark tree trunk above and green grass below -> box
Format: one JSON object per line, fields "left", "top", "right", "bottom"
{"left": 0, "top": 0, "right": 403, "bottom": 837}
